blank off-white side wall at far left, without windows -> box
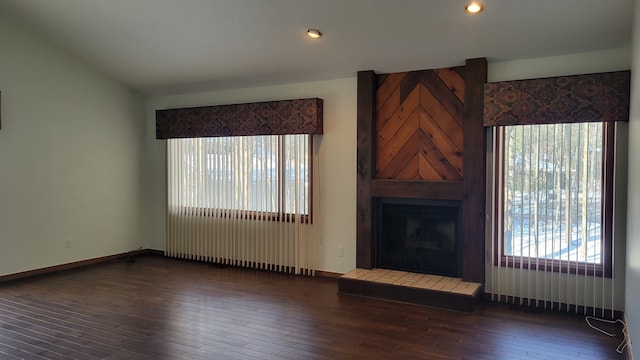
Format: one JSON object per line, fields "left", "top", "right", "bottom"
{"left": 0, "top": 14, "right": 145, "bottom": 275}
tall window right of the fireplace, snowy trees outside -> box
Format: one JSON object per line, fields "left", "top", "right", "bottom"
{"left": 496, "top": 122, "right": 613, "bottom": 276}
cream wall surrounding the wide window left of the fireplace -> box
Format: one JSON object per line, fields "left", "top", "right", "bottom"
{"left": 147, "top": 77, "right": 357, "bottom": 273}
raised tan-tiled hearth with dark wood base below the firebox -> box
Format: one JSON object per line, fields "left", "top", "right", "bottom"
{"left": 339, "top": 269, "right": 482, "bottom": 312}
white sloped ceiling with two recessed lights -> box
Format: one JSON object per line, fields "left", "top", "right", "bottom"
{"left": 0, "top": 0, "right": 634, "bottom": 93}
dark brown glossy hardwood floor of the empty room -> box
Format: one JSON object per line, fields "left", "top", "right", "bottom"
{"left": 0, "top": 255, "right": 625, "bottom": 360}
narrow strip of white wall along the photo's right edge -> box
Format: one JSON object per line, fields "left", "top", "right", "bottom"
{"left": 625, "top": 1, "right": 640, "bottom": 354}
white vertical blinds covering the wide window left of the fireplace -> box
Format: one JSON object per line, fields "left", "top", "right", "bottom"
{"left": 167, "top": 135, "right": 316, "bottom": 275}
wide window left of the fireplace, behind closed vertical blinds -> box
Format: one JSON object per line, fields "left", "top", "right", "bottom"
{"left": 168, "top": 135, "right": 311, "bottom": 221}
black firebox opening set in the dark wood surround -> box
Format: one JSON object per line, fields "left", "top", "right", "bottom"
{"left": 376, "top": 198, "right": 462, "bottom": 277}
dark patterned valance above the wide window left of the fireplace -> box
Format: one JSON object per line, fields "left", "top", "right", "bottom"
{"left": 156, "top": 98, "right": 322, "bottom": 139}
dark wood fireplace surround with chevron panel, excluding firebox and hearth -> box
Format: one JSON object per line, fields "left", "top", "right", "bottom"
{"left": 356, "top": 59, "right": 487, "bottom": 284}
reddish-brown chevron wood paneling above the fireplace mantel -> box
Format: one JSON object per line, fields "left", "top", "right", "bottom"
{"left": 375, "top": 67, "right": 464, "bottom": 181}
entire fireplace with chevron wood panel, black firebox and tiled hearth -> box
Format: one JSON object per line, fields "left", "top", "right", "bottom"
{"left": 348, "top": 63, "right": 487, "bottom": 311}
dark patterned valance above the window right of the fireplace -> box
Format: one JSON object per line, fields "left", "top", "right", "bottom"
{"left": 484, "top": 71, "right": 631, "bottom": 127}
